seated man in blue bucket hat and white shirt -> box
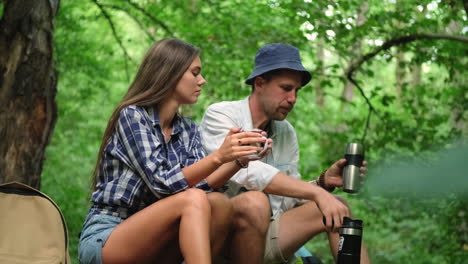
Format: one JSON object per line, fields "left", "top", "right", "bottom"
{"left": 201, "top": 43, "right": 368, "bottom": 263}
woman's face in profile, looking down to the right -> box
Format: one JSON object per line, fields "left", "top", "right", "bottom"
{"left": 174, "top": 57, "right": 206, "bottom": 104}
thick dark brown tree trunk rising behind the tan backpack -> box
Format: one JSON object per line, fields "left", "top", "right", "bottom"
{"left": 0, "top": 0, "right": 60, "bottom": 188}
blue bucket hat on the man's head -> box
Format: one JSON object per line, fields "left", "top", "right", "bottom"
{"left": 245, "top": 43, "right": 312, "bottom": 86}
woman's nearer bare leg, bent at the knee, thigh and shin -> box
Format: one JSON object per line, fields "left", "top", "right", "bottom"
{"left": 102, "top": 188, "right": 211, "bottom": 264}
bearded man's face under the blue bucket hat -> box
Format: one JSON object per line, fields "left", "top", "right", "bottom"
{"left": 255, "top": 70, "right": 302, "bottom": 120}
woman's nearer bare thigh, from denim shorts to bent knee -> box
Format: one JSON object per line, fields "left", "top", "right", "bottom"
{"left": 102, "top": 189, "right": 208, "bottom": 263}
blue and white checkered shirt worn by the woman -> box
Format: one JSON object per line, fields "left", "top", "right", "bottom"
{"left": 90, "top": 105, "right": 213, "bottom": 219}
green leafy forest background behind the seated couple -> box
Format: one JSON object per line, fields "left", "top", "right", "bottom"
{"left": 0, "top": 0, "right": 468, "bottom": 264}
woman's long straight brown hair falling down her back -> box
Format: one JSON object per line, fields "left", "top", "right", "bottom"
{"left": 91, "top": 39, "right": 200, "bottom": 191}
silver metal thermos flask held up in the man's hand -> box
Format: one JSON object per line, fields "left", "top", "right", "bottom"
{"left": 343, "top": 143, "right": 364, "bottom": 193}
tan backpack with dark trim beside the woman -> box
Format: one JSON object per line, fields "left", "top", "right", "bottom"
{"left": 0, "top": 182, "right": 71, "bottom": 264}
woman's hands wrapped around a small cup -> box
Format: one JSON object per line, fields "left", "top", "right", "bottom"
{"left": 215, "top": 128, "right": 271, "bottom": 163}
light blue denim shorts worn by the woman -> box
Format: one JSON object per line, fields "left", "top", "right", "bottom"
{"left": 78, "top": 215, "right": 123, "bottom": 264}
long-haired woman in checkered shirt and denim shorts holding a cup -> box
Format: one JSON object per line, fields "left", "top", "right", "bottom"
{"left": 79, "top": 39, "right": 271, "bottom": 264}
